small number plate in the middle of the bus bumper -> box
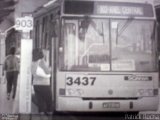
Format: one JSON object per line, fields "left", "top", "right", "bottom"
{"left": 102, "top": 102, "right": 120, "bottom": 108}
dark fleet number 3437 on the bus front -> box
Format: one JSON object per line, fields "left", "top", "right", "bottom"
{"left": 66, "top": 76, "right": 96, "bottom": 86}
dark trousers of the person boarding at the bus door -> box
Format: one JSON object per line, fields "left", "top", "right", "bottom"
{"left": 34, "top": 85, "right": 52, "bottom": 112}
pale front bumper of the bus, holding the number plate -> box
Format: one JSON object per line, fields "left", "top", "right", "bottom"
{"left": 56, "top": 96, "right": 159, "bottom": 112}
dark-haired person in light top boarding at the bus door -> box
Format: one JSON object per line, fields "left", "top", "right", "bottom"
{"left": 31, "top": 48, "right": 52, "bottom": 114}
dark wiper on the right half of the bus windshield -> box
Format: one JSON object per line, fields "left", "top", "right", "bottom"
{"left": 116, "top": 17, "right": 134, "bottom": 44}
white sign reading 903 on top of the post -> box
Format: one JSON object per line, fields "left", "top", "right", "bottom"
{"left": 15, "top": 16, "right": 33, "bottom": 32}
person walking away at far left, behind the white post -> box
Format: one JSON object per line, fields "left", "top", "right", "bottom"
{"left": 3, "top": 47, "right": 19, "bottom": 100}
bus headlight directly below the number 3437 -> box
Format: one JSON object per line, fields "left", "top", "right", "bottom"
{"left": 66, "top": 88, "right": 84, "bottom": 96}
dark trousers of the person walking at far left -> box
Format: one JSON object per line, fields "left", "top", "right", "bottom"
{"left": 6, "top": 71, "right": 18, "bottom": 99}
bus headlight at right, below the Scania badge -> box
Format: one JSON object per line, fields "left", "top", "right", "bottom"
{"left": 138, "top": 89, "right": 154, "bottom": 96}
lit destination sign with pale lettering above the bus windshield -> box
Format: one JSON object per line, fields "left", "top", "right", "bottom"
{"left": 95, "top": 2, "right": 153, "bottom": 17}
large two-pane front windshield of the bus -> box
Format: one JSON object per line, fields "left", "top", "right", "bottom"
{"left": 60, "top": 17, "right": 156, "bottom": 71}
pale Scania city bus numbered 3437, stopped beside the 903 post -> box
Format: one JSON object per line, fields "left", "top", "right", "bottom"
{"left": 33, "top": 0, "right": 159, "bottom": 112}
